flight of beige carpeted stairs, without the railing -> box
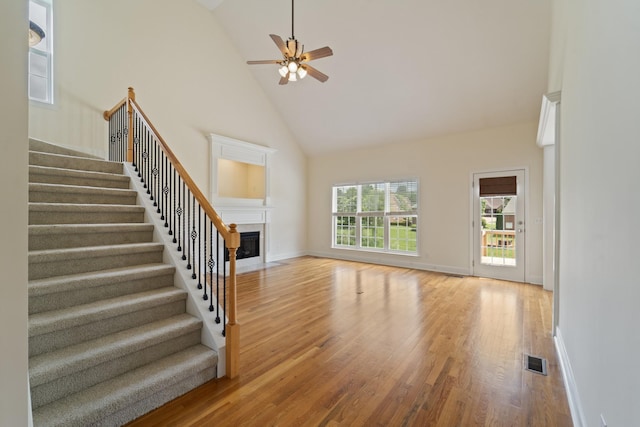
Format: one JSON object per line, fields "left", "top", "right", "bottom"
{"left": 29, "top": 140, "right": 217, "bottom": 427}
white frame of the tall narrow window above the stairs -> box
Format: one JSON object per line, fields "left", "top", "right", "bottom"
{"left": 27, "top": 0, "right": 54, "bottom": 105}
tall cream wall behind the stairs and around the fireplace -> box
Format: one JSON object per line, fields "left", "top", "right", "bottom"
{"left": 29, "top": 0, "right": 306, "bottom": 259}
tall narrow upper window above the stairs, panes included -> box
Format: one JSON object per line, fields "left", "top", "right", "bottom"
{"left": 29, "top": 0, "right": 53, "bottom": 104}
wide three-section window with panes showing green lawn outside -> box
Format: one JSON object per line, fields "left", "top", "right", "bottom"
{"left": 333, "top": 180, "right": 418, "bottom": 255}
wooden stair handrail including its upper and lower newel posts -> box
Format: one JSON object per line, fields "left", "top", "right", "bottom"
{"left": 103, "top": 87, "right": 240, "bottom": 378}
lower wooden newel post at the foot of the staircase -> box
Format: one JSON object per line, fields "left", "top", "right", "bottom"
{"left": 225, "top": 224, "right": 240, "bottom": 378}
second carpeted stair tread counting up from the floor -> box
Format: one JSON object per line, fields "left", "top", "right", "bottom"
{"left": 29, "top": 314, "right": 202, "bottom": 387}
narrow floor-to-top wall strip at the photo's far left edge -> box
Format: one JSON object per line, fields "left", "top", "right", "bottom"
{"left": 0, "top": 1, "right": 29, "bottom": 426}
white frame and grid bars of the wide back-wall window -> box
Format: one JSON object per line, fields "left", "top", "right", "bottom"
{"left": 331, "top": 178, "right": 420, "bottom": 256}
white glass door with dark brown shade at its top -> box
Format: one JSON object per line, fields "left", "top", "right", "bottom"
{"left": 472, "top": 169, "right": 526, "bottom": 282}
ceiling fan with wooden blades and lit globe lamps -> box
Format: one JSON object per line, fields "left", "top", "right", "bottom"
{"left": 247, "top": 0, "right": 333, "bottom": 85}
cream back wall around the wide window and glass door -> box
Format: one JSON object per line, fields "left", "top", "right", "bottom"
{"left": 308, "top": 123, "right": 542, "bottom": 283}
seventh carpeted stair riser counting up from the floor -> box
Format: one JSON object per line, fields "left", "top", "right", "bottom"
{"left": 29, "top": 210, "right": 144, "bottom": 225}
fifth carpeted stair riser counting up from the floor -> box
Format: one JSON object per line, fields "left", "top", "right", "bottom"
{"left": 29, "top": 247, "right": 162, "bottom": 280}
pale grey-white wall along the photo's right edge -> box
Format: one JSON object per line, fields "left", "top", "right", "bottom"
{"left": 550, "top": 0, "right": 640, "bottom": 426}
